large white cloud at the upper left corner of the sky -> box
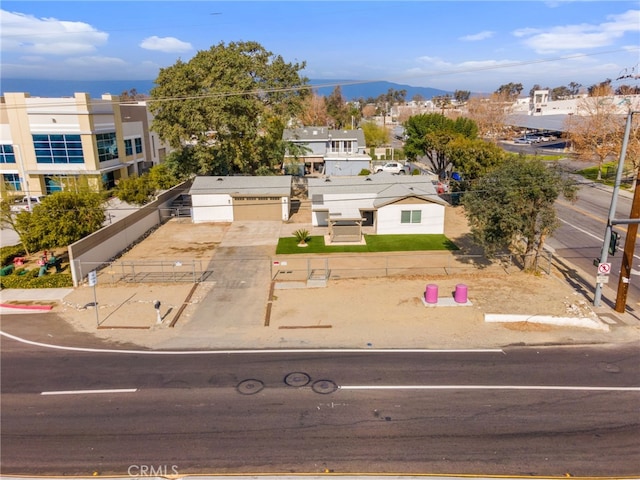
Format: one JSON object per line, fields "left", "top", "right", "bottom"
{"left": 0, "top": 10, "right": 109, "bottom": 55}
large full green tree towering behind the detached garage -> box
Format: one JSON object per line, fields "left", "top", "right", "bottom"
{"left": 149, "top": 42, "right": 309, "bottom": 175}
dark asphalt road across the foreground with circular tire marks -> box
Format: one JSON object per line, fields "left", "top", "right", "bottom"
{"left": 0, "top": 337, "right": 640, "bottom": 476}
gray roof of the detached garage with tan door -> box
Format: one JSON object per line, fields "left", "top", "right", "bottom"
{"left": 189, "top": 175, "right": 291, "bottom": 197}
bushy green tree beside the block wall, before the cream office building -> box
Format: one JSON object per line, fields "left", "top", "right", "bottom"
{"left": 16, "top": 191, "right": 105, "bottom": 251}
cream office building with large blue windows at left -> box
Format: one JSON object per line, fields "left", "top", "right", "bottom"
{"left": 0, "top": 92, "right": 167, "bottom": 195}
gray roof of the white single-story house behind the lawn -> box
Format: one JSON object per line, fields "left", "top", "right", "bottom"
{"left": 308, "top": 172, "right": 448, "bottom": 208}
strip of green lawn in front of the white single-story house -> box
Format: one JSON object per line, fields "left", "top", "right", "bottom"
{"left": 276, "top": 235, "right": 458, "bottom": 255}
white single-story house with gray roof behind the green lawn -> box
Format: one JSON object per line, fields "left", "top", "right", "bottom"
{"left": 308, "top": 173, "right": 448, "bottom": 241}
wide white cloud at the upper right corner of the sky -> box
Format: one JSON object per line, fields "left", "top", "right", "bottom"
{"left": 513, "top": 10, "right": 640, "bottom": 53}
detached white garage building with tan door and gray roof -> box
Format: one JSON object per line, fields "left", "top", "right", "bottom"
{"left": 189, "top": 175, "right": 291, "bottom": 223}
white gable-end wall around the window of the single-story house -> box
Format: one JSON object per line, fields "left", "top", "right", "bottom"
{"left": 376, "top": 203, "right": 445, "bottom": 235}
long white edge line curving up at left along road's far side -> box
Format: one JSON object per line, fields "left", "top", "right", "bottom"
{"left": 0, "top": 331, "right": 504, "bottom": 355}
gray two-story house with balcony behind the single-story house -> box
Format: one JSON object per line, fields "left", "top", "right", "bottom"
{"left": 282, "top": 127, "right": 371, "bottom": 176}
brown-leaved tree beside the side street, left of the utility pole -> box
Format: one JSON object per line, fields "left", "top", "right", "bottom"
{"left": 565, "top": 86, "right": 624, "bottom": 180}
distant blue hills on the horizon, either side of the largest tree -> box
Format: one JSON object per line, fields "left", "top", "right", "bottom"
{"left": 0, "top": 78, "right": 453, "bottom": 100}
